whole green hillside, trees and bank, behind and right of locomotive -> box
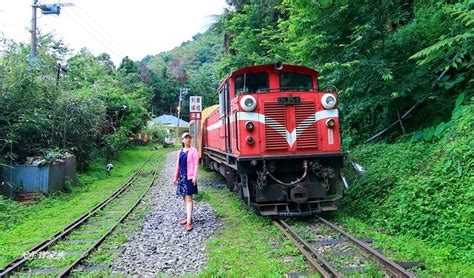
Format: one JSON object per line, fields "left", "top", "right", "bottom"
{"left": 148, "top": 0, "right": 474, "bottom": 266}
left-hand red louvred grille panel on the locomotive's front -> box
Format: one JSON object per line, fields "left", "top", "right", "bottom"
{"left": 264, "top": 102, "right": 288, "bottom": 150}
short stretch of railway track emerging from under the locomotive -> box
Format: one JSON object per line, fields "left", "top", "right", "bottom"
{"left": 274, "top": 217, "right": 416, "bottom": 277}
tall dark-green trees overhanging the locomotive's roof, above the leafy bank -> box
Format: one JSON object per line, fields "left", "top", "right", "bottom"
{"left": 218, "top": 0, "right": 474, "bottom": 145}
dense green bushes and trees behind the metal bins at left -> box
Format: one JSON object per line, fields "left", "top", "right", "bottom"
{"left": 0, "top": 35, "right": 152, "bottom": 168}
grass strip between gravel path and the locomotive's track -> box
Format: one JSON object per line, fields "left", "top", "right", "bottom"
{"left": 196, "top": 169, "right": 308, "bottom": 277}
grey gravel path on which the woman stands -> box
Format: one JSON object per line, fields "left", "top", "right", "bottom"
{"left": 111, "top": 152, "right": 220, "bottom": 276}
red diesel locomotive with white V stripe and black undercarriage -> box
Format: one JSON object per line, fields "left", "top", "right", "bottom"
{"left": 202, "top": 63, "right": 344, "bottom": 216}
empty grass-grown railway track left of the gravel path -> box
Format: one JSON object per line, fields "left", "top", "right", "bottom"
{"left": 0, "top": 159, "right": 158, "bottom": 277}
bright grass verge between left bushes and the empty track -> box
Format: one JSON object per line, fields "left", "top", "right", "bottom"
{"left": 0, "top": 146, "right": 169, "bottom": 266}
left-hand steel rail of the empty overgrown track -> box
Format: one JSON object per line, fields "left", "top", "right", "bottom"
{"left": 0, "top": 158, "right": 151, "bottom": 277}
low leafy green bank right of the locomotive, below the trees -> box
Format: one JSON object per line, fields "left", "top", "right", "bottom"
{"left": 343, "top": 99, "right": 474, "bottom": 265}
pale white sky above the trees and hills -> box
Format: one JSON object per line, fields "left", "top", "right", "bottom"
{"left": 0, "top": 0, "right": 227, "bottom": 65}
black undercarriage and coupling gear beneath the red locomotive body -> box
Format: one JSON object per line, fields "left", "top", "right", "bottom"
{"left": 203, "top": 148, "right": 344, "bottom": 217}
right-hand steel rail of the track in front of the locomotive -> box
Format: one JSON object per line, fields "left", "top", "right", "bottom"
{"left": 318, "top": 216, "right": 416, "bottom": 278}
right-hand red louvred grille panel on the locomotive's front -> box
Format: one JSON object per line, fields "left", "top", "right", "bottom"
{"left": 295, "top": 101, "right": 318, "bottom": 149}
